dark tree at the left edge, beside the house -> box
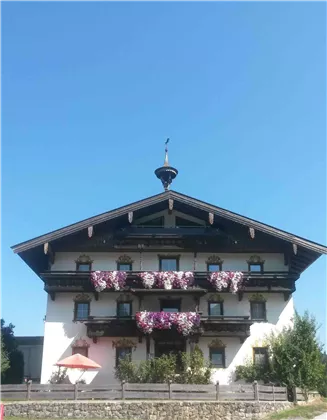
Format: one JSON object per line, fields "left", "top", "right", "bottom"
{"left": 0, "top": 319, "right": 24, "bottom": 384}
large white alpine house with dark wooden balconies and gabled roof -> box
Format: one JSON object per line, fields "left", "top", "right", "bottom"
{"left": 13, "top": 157, "right": 326, "bottom": 385}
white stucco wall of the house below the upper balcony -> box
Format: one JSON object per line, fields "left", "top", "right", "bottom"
{"left": 41, "top": 293, "right": 294, "bottom": 384}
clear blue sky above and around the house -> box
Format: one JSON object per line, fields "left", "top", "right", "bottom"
{"left": 1, "top": 1, "right": 326, "bottom": 339}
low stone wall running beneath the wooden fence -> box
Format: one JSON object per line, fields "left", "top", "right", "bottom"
{"left": 5, "top": 401, "right": 292, "bottom": 420}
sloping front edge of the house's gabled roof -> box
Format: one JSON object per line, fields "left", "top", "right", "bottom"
{"left": 12, "top": 191, "right": 327, "bottom": 254}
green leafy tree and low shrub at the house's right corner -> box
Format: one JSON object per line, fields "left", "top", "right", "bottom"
{"left": 236, "top": 312, "right": 326, "bottom": 395}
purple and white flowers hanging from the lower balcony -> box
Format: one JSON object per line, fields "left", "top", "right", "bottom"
{"left": 135, "top": 311, "right": 200, "bottom": 336}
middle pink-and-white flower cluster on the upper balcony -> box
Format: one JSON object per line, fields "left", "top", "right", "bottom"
{"left": 139, "top": 271, "right": 194, "bottom": 290}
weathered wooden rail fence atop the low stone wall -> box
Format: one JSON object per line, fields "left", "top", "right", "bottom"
{"left": 0, "top": 382, "right": 292, "bottom": 401}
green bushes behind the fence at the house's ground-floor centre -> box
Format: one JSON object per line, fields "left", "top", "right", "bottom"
{"left": 115, "top": 348, "right": 210, "bottom": 384}
